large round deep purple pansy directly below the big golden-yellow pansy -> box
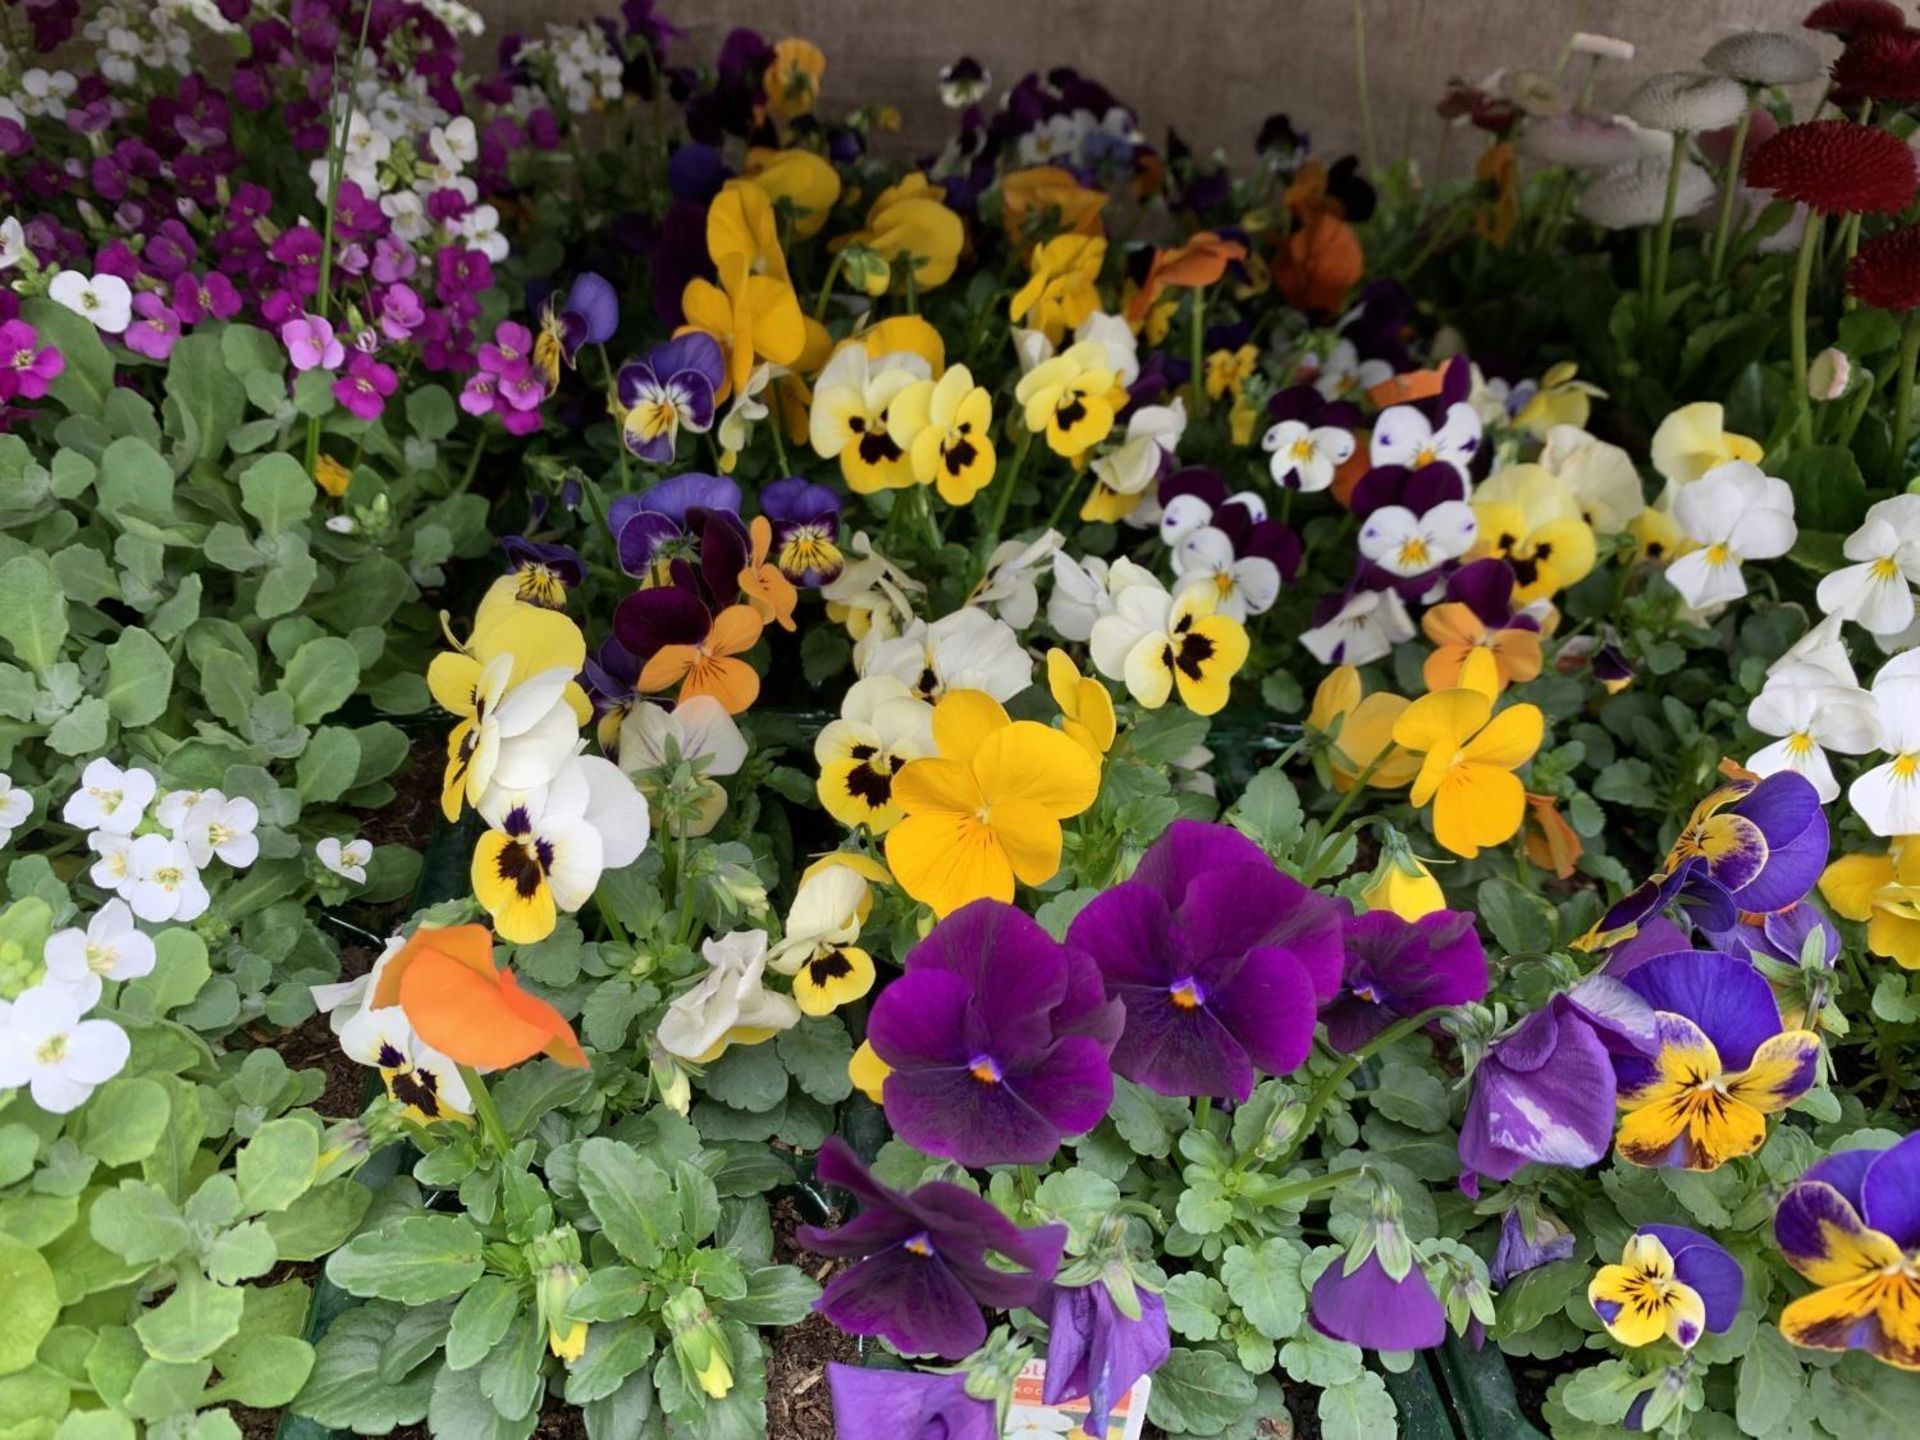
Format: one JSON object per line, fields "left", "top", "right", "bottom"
{"left": 866, "top": 900, "right": 1121, "bottom": 1165}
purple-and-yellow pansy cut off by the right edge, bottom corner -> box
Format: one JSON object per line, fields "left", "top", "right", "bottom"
{"left": 1774, "top": 1135, "right": 1920, "bottom": 1371}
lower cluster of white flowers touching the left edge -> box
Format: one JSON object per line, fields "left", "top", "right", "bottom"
{"left": 0, "top": 900, "right": 156, "bottom": 1116}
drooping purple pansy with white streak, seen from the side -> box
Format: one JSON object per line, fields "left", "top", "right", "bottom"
{"left": 1459, "top": 975, "right": 1655, "bottom": 1194}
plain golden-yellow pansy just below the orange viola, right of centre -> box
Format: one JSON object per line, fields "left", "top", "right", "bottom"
{"left": 1394, "top": 689, "right": 1546, "bottom": 860}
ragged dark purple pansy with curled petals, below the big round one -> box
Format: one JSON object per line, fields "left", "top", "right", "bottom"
{"left": 795, "top": 1135, "right": 1068, "bottom": 1359}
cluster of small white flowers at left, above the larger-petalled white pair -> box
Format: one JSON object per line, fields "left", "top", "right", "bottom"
{"left": 60, "top": 756, "right": 259, "bottom": 922}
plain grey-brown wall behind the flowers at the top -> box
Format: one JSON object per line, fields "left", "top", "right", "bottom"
{"left": 478, "top": 0, "right": 1837, "bottom": 169}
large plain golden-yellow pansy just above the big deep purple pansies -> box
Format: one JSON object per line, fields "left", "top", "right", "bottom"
{"left": 887, "top": 689, "right": 1100, "bottom": 916}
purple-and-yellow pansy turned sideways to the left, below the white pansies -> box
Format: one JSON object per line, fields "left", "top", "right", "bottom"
{"left": 1599, "top": 770, "right": 1828, "bottom": 935}
